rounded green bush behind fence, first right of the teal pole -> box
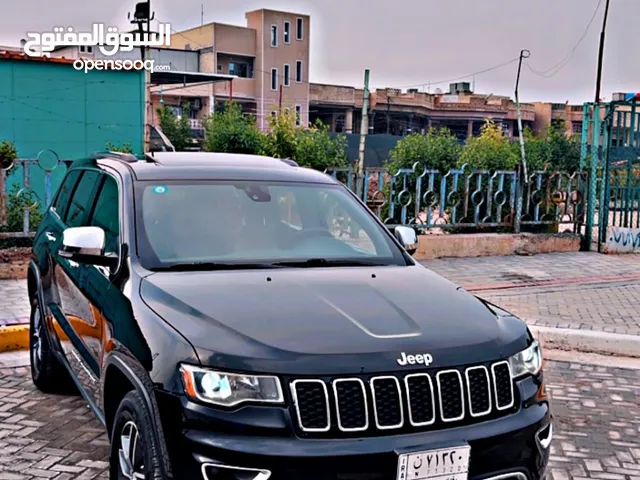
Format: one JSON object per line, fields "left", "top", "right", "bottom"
{"left": 386, "top": 127, "right": 462, "bottom": 173}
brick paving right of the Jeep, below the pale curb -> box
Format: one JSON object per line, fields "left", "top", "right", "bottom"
{"left": 546, "top": 362, "right": 640, "bottom": 480}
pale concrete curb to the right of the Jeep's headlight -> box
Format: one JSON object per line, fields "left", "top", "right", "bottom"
{"left": 529, "top": 325, "right": 640, "bottom": 358}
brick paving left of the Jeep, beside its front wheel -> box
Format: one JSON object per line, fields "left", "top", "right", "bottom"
{"left": 0, "top": 367, "right": 109, "bottom": 480}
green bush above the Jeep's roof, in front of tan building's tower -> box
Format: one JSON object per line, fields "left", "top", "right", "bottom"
{"left": 203, "top": 101, "right": 265, "bottom": 155}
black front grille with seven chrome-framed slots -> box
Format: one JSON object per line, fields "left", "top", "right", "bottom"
{"left": 290, "top": 361, "right": 515, "bottom": 435}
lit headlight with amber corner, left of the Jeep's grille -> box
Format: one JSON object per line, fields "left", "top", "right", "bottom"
{"left": 180, "top": 365, "right": 284, "bottom": 407}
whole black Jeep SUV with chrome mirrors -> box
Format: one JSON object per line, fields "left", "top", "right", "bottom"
{"left": 28, "top": 152, "right": 552, "bottom": 480}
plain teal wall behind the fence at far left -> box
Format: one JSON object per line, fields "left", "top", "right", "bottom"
{"left": 0, "top": 57, "right": 144, "bottom": 210}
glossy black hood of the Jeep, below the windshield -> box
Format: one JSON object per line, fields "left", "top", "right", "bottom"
{"left": 140, "top": 265, "right": 530, "bottom": 374}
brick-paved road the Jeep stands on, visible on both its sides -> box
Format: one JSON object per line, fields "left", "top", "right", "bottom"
{"left": 0, "top": 354, "right": 640, "bottom": 480}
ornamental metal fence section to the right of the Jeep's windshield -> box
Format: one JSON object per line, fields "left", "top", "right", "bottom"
{"left": 326, "top": 163, "right": 588, "bottom": 233}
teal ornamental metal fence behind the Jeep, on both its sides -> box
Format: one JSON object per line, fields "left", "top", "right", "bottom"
{"left": 0, "top": 156, "right": 589, "bottom": 239}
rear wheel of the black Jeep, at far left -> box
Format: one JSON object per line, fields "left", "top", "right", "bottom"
{"left": 29, "top": 298, "right": 72, "bottom": 393}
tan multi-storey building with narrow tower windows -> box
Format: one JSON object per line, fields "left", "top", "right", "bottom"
{"left": 164, "top": 9, "right": 310, "bottom": 129}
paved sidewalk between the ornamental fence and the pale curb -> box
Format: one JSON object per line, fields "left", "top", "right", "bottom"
{"left": 422, "top": 252, "right": 640, "bottom": 335}
